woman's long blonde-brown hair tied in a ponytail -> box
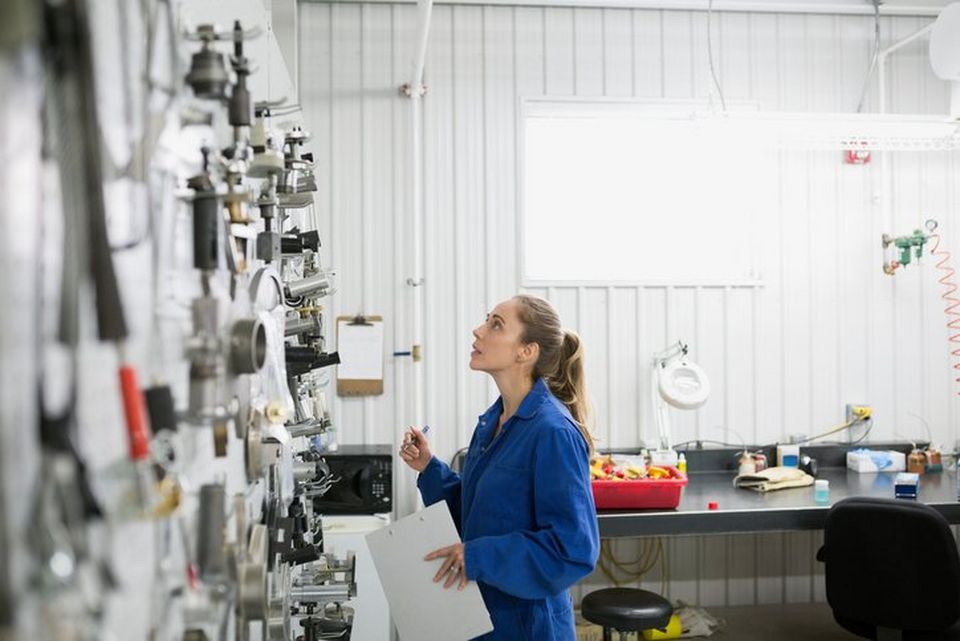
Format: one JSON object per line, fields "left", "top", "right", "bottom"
{"left": 513, "top": 294, "right": 593, "bottom": 456}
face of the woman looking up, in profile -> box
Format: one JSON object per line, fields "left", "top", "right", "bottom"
{"left": 470, "top": 299, "right": 533, "bottom": 373}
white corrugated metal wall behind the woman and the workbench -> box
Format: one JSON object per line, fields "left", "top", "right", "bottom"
{"left": 300, "top": 3, "right": 960, "bottom": 605}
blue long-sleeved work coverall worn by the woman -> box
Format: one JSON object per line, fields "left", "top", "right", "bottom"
{"left": 417, "top": 379, "right": 600, "bottom": 641}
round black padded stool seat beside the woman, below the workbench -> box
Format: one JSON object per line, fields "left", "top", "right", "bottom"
{"left": 580, "top": 588, "right": 673, "bottom": 641}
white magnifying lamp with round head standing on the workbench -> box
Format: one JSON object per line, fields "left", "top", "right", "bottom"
{"left": 650, "top": 341, "right": 710, "bottom": 466}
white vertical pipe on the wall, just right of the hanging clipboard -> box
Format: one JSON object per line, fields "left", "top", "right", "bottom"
{"left": 408, "top": 0, "right": 433, "bottom": 428}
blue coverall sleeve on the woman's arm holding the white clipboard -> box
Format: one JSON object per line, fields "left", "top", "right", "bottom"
{"left": 464, "top": 430, "right": 600, "bottom": 599}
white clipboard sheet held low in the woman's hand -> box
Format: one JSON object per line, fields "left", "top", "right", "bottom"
{"left": 367, "top": 501, "right": 493, "bottom": 641}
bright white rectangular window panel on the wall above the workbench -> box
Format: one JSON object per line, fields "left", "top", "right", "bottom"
{"left": 520, "top": 100, "right": 771, "bottom": 284}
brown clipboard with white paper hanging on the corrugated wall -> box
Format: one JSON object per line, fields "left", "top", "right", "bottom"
{"left": 337, "top": 315, "right": 383, "bottom": 396}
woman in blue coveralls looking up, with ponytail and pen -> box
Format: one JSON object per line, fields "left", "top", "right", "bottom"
{"left": 400, "top": 296, "right": 600, "bottom": 641}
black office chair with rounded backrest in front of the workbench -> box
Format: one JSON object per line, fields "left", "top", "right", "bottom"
{"left": 817, "top": 498, "right": 960, "bottom": 641}
